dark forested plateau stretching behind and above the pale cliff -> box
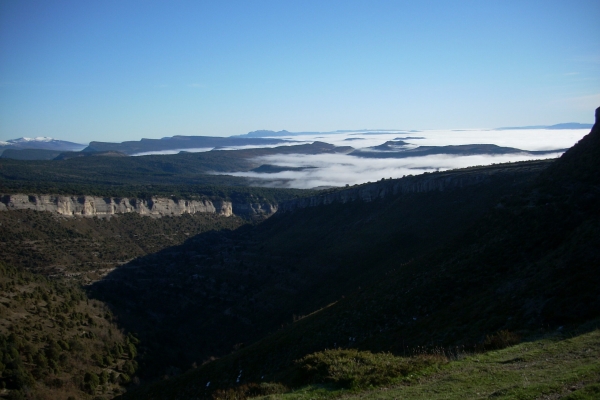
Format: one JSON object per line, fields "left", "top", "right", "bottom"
{"left": 0, "top": 142, "right": 345, "bottom": 198}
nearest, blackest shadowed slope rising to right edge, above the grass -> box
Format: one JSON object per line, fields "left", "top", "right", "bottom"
{"left": 120, "top": 110, "right": 600, "bottom": 398}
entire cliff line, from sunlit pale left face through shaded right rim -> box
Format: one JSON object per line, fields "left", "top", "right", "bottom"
{"left": 0, "top": 161, "right": 549, "bottom": 218}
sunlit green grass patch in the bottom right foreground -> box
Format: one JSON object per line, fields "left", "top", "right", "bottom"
{"left": 254, "top": 330, "right": 600, "bottom": 400}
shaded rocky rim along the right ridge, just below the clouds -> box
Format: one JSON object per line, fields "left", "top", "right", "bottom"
{"left": 279, "top": 160, "right": 551, "bottom": 212}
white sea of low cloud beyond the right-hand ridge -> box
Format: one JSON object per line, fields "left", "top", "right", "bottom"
{"left": 221, "top": 129, "right": 588, "bottom": 189}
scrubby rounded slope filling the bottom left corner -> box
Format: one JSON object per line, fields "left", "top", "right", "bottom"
{"left": 0, "top": 264, "right": 139, "bottom": 399}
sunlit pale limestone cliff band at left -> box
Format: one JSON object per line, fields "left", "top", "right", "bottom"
{"left": 0, "top": 194, "right": 233, "bottom": 217}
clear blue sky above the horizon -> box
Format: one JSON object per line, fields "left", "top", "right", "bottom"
{"left": 0, "top": 0, "right": 600, "bottom": 143}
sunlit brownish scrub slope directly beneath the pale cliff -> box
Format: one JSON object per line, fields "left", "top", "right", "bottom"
{"left": 0, "top": 210, "right": 247, "bottom": 282}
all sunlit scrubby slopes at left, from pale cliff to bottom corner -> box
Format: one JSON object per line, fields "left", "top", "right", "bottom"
{"left": 0, "top": 210, "right": 252, "bottom": 399}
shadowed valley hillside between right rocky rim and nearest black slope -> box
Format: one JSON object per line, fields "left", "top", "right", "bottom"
{"left": 91, "top": 159, "right": 538, "bottom": 378}
